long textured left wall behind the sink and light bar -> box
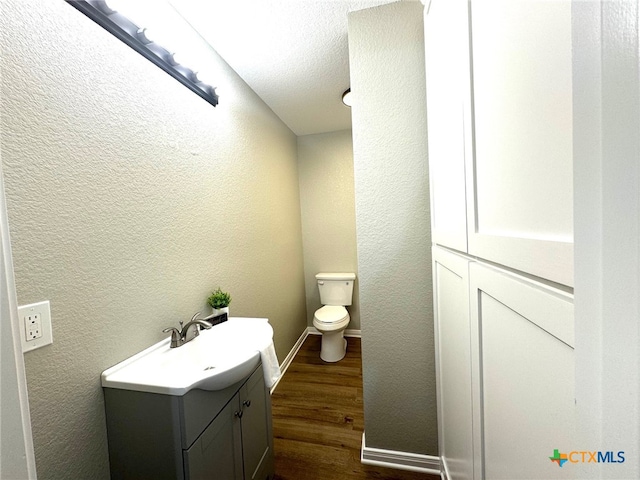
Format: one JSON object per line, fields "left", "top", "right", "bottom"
{"left": 0, "top": 0, "right": 306, "bottom": 479}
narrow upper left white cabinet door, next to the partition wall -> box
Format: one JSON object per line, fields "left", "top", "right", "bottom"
{"left": 424, "top": 0, "right": 469, "bottom": 252}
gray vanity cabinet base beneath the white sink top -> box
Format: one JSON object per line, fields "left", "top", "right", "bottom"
{"left": 104, "top": 365, "right": 273, "bottom": 480}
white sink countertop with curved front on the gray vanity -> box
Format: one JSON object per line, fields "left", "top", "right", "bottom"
{"left": 102, "top": 317, "right": 273, "bottom": 395}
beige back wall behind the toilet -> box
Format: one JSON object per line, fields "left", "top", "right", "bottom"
{"left": 298, "top": 130, "right": 360, "bottom": 329}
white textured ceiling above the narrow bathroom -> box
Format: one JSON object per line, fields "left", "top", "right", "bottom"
{"left": 172, "top": 0, "right": 392, "bottom": 135}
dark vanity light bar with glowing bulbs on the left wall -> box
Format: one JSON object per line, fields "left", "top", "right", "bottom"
{"left": 65, "top": 0, "right": 218, "bottom": 107}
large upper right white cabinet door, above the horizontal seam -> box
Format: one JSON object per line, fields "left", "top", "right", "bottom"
{"left": 462, "top": 0, "right": 573, "bottom": 286}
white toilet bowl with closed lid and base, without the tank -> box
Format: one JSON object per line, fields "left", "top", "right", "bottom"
{"left": 313, "top": 305, "right": 351, "bottom": 362}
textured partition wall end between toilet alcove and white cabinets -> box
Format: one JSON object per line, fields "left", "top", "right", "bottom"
{"left": 349, "top": 2, "right": 437, "bottom": 455}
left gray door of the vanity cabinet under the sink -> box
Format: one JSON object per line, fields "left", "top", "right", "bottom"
{"left": 183, "top": 394, "right": 243, "bottom": 480}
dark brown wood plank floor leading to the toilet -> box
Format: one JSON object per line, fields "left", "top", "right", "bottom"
{"left": 271, "top": 335, "right": 440, "bottom": 480}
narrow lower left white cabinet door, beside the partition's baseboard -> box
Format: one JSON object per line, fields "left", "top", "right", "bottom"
{"left": 433, "top": 247, "right": 473, "bottom": 480}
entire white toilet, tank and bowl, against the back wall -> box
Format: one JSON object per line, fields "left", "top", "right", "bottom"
{"left": 313, "top": 273, "right": 356, "bottom": 362}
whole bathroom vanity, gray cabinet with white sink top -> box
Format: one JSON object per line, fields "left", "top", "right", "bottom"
{"left": 102, "top": 317, "right": 274, "bottom": 480}
